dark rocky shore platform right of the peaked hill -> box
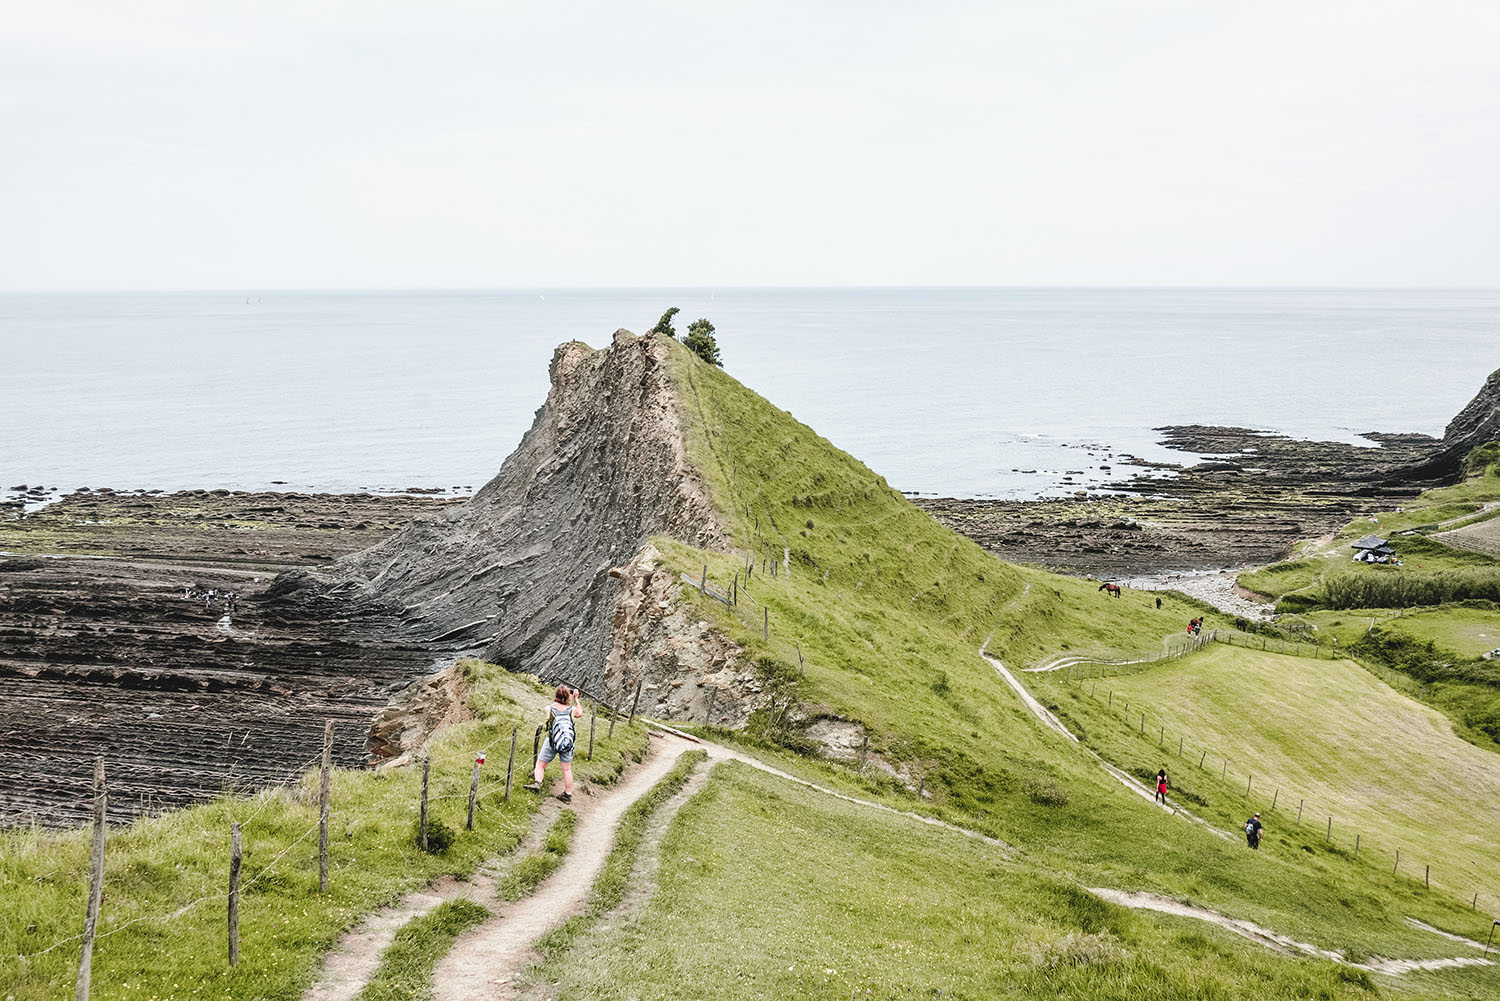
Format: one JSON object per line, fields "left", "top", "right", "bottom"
{"left": 914, "top": 425, "right": 1440, "bottom": 578}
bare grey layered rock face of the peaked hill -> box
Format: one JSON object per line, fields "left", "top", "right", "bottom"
{"left": 272, "top": 330, "right": 753, "bottom": 717}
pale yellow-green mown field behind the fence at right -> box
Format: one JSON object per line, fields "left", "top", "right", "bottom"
{"left": 1026, "top": 647, "right": 1500, "bottom": 905}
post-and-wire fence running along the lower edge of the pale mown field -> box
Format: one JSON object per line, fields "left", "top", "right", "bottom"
{"left": 1064, "top": 675, "right": 1500, "bottom": 909}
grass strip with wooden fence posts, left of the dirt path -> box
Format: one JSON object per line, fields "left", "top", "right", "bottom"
{"left": 0, "top": 663, "right": 645, "bottom": 1001}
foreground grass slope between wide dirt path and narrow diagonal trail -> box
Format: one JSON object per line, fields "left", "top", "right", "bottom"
{"left": 558, "top": 764, "right": 1416, "bottom": 999}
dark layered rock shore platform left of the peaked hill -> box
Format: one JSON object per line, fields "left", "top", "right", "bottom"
{"left": 0, "top": 489, "right": 455, "bottom": 825}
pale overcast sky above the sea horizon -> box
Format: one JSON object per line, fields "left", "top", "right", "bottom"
{"left": 0, "top": 0, "right": 1500, "bottom": 290}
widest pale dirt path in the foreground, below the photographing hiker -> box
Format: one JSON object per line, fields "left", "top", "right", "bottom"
{"left": 432, "top": 732, "right": 695, "bottom": 1001}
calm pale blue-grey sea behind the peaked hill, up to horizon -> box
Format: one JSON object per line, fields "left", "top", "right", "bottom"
{"left": 0, "top": 288, "right": 1500, "bottom": 497}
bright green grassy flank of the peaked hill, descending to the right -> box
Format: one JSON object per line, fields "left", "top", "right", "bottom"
{"left": 660, "top": 340, "right": 1500, "bottom": 990}
